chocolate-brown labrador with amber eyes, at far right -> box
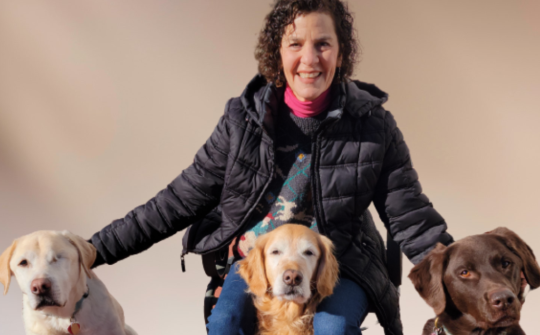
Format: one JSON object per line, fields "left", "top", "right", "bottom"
{"left": 409, "top": 228, "right": 540, "bottom": 335}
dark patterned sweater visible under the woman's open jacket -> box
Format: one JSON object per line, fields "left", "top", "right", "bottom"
{"left": 235, "top": 103, "right": 326, "bottom": 258}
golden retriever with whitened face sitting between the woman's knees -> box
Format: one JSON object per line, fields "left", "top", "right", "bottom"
{"left": 238, "top": 224, "right": 339, "bottom": 335}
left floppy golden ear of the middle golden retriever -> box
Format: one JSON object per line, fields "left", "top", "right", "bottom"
{"left": 238, "top": 234, "right": 268, "bottom": 296}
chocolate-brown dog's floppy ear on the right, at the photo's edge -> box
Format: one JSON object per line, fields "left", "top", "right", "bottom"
{"left": 488, "top": 227, "right": 540, "bottom": 289}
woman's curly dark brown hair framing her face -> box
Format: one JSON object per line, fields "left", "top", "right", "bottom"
{"left": 255, "top": 0, "right": 360, "bottom": 86}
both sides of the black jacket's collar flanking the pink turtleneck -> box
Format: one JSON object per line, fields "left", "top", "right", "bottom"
{"left": 240, "top": 74, "right": 388, "bottom": 137}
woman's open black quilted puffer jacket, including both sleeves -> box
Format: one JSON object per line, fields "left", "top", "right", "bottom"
{"left": 91, "top": 76, "right": 452, "bottom": 335}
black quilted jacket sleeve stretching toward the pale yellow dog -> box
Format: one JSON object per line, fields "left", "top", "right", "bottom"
{"left": 89, "top": 108, "right": 230, "bottom": 267}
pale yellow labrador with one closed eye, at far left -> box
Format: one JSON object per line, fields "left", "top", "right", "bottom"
{"left": 0, "top": 231, "right": 136, "bottom": 335}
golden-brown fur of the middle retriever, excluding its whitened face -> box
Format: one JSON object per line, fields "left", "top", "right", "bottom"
{"left": 239, "top": 225, "right": 339, "bottom": 335}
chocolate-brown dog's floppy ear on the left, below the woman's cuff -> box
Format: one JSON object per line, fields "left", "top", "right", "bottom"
{"left": 409, "top": 243, "right": 446, "bottom": 315}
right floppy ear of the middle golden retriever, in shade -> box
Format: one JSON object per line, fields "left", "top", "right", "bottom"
{"left": 315, "top": 235, "right": 339, "bottom": 298}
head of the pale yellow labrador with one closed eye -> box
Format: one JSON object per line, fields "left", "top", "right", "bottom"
{"left": 0, "top": 231, "right": 96, "bottom": 314}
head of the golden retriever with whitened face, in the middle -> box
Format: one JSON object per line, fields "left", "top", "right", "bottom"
{"left": 239, "top": 224, "right": 338, "bottom": 304}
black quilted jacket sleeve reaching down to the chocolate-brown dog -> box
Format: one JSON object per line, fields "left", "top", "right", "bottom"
{"left": 373, "top": 112, "right": 453, "bottom": 264}
